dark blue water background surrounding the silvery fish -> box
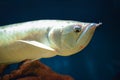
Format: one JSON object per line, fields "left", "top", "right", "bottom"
{"left": 0, "top": 0, "right": 120, "bottom": 80}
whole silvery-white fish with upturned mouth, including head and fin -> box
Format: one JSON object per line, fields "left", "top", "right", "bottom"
{"left": 0, "top": 20, "right": 100, "bottom": 64}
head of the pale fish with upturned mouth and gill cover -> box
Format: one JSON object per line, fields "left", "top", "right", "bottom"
{"left": 48, "top": 22, "right": 101, "bottom": 56}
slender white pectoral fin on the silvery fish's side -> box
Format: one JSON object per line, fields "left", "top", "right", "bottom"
{"left": 18, "top": 40, "right": 55, "bottom": 51}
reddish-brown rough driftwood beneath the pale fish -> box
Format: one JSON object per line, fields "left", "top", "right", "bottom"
{"left": 0, "top": 60, "right": 73, "bottom": 80}
